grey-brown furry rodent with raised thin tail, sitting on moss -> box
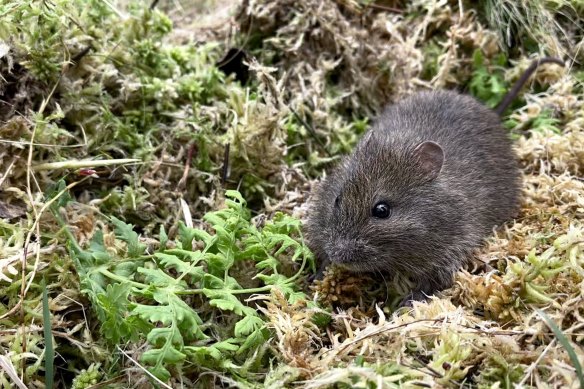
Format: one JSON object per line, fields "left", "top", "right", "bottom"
{"left": 304, "top": 58, "right": 563, "bottom": 306}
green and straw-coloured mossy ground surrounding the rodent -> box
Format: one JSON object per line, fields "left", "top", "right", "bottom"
{"left": 0, "top": 0, "right": 584, "bottom": 388}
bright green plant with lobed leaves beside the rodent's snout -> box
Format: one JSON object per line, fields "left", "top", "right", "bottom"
{"left": 53, "top": 186, "right": 314, "bottom": 382}
